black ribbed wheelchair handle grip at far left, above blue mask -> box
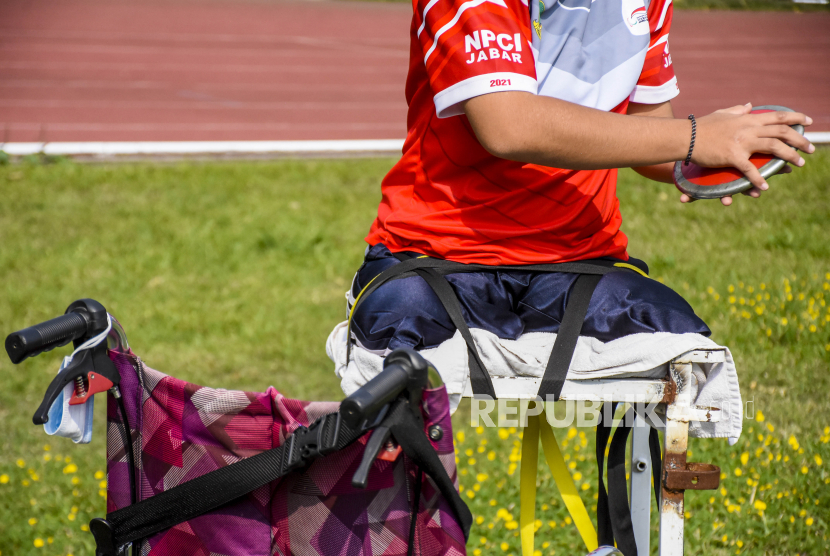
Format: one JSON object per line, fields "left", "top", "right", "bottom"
{"left": 6, "top": 312, "right": 89, "bottom": 364}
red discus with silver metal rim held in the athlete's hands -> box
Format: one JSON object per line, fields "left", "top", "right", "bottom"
{"left": 674, "top": 106, "right": 804, "bottom": 199}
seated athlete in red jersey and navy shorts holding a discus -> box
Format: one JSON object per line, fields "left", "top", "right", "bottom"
{"left": 342, "top": 0, "right": 814, "bottom": 378}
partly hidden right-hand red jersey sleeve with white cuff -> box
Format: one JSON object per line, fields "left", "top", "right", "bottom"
{"left": 629, "top": 0, "right": 680, "bottom": 104}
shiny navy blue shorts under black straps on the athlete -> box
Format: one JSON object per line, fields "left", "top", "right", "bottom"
{"left": 352, "top": 244, "right": 711, "bottom": 351}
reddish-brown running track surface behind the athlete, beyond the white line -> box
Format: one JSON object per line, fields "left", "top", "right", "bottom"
{"left": 0, "top": 0, "right": 830, "bottom": 142}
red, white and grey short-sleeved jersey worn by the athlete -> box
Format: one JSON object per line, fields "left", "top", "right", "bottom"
{"left": 366, "top": 0, "right": 677, "bottom": 265}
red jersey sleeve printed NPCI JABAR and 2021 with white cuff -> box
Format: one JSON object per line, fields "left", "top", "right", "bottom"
{"left": 414, "top": 0, "right": 536, "bottom": 118}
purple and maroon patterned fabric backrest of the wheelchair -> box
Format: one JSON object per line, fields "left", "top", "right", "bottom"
{"left": 107, "top": 352, "right": 466, "bottom": 556}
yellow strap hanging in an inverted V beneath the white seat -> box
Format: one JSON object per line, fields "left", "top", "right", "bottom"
{"left": 519, "top": 404, "right": 598, "bottom": 556}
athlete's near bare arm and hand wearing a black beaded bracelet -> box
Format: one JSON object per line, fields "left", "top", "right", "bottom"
{"left": 463, "top": 91, "right": 815, "bottom": 190}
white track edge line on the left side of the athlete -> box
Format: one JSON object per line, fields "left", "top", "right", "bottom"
{"left": 0, "top": 139, "right": 404, "bottom": 156}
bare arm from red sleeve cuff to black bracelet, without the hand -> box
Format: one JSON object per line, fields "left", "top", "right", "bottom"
{"left": 465, "top": 91, "right": 692, "bottom": 170}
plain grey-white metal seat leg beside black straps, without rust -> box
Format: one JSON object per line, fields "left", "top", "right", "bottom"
{"left": 629, "top": 415, "right": 651, "bottom": 556}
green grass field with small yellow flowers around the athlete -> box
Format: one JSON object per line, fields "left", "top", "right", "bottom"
{"left": 0, "top": 150, "right": 830, "bottom": 556}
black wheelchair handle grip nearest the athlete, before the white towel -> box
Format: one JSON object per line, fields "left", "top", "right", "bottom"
{"left": 340, "top": 349, "right": 429, "bottom": 427}
